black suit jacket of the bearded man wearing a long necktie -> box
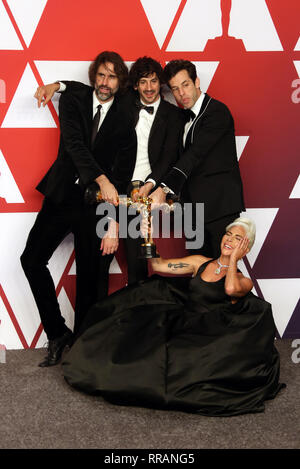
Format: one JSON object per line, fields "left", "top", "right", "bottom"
{"left": 37, "top": 85, "right": 136, "bottom": 203}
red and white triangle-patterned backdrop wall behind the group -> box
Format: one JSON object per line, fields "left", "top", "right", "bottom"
{"left": 0, "top": 0, "right": 300, "bottom": 348}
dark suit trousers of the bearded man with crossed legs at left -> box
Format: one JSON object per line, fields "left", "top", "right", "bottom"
{"left": 21, "top": 185, "right": 113, "bottom": 340}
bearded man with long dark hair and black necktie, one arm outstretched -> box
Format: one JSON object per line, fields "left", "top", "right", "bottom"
{"left": 21, "top": 52, "right": 135, "bottom": 367}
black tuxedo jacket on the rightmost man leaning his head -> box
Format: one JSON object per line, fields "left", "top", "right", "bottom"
{"left": 162, "top": 95, "right": 244, "bottom": 223}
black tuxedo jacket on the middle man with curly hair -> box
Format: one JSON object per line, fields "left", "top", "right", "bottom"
{"left": 123, "top": 91, "right": 185, "bottom": 184}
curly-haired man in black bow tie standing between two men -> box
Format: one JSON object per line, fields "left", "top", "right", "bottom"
{"left": 125, "top": 57, "right": 184, "bottom": 284}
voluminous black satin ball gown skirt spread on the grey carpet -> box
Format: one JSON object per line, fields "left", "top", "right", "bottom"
{"left": 62, "top": 263, "right": 284, "bottom": 416}
